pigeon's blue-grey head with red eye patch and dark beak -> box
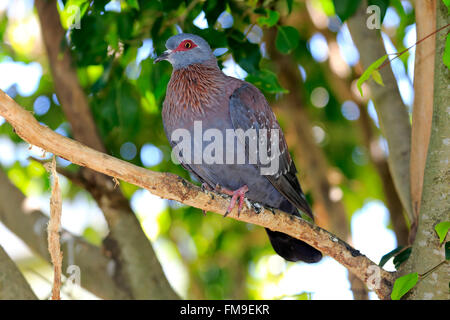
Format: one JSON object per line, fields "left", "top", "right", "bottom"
{"left": 154, "top": 33, "right": 215, "bottom": 69}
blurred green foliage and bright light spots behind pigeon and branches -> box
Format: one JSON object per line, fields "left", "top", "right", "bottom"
{"left": 0, "top": 0, "right": 415, "bottom": 299}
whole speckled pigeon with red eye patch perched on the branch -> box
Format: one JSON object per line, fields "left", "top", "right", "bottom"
{"left": 154, "top": 33, "right": 322, "bottom": 263}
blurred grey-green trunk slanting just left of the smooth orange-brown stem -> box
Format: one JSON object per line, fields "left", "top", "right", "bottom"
{"left": 348, "top": 1, "right": 415, "bottom": 223}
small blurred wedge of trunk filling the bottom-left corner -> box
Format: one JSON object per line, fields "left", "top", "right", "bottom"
{"left": 0, "top": 246, "right": 37, "bottom": 300}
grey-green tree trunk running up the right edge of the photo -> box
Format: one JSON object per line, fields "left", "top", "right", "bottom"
{"left": 402, "top": 1, "right": 450, "bottom": 300}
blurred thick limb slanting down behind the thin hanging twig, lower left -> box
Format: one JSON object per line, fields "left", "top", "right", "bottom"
{"left": 0, "top": 170, "right": 131, "bottom": 300}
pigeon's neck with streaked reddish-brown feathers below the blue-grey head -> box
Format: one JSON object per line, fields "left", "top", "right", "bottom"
{"left": 164, "top": 63, "right": 225, "bottom": 118}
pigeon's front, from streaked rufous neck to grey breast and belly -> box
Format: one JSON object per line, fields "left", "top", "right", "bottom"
{"left": 163, "top": 65, "right": 295, "bottom": 211}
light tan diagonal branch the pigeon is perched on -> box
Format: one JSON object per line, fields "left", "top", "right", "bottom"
{"left": 0, "top": 91, "right": 395, "bottom": 299}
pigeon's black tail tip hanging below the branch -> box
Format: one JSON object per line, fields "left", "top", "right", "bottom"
{"left": 266, "top": 228, "right": 322, "bottom": 263}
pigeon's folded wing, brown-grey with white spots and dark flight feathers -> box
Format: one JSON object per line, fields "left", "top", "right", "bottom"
{"left": 230, "top": 83, "right": 313, "bottom": 218}
